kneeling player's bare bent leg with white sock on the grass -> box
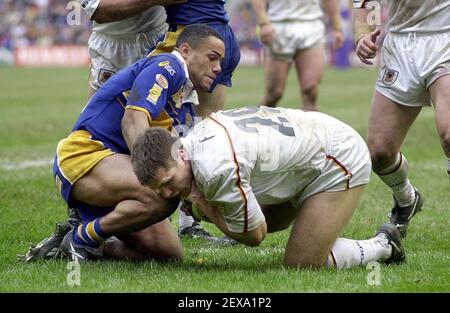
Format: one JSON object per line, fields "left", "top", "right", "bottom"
{"left": 284, "top": 186, "right": 404, "bottom": 268}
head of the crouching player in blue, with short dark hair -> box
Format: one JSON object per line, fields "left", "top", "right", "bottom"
{"left": 176, "top": 24, "right": 225, "bottom": 91}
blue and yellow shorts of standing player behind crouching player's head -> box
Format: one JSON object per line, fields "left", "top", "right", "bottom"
{"left": 148, "top": 23, "right": 241, "bottom": 92}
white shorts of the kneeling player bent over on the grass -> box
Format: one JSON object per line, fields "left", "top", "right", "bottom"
{"left": 291, "top": 112, "right": 372, "bottom": 208}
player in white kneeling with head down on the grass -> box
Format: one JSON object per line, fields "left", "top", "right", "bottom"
{"left": 132, "top": 107, "right": 405, "bottom": 268}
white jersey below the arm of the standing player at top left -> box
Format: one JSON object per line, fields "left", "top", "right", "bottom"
{"left": 78, "top": 0, "right": 166, "bottom": 36}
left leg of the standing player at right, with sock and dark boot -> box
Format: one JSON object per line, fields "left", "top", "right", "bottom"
{"left": 367, "top": 91, "right": 422, "bottom": 236}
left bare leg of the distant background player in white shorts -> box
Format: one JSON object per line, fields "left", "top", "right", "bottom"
{"left": 261, "top": 52, "right": 291, "bottom": 107}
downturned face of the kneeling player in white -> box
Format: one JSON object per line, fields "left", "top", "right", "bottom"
{"left": 150, "top": 156, "right": 193, "bottom": 199}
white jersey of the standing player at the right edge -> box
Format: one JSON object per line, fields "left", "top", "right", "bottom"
{"left": 353, "top": 0, "right": 450, "bottom": 33}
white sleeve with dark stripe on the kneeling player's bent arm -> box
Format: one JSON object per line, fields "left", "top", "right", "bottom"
{"left": 197, "top": 161, "right": 265, "bottom": 233}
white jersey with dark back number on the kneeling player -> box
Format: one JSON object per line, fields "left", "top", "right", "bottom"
{"left": 181, "top": 107, "right": 341, "bottom": 233}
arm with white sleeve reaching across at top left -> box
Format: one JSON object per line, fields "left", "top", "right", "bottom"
{"left": 79, "top": 0, "right": 187, "bottom": 23}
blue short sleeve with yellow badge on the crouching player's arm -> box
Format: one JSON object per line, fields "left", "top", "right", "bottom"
{"left": 126, "top": 61, "right": 186, "bottom": 123}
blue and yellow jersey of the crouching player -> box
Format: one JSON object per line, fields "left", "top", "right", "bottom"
{"left": 72, "top": 51, "right": 195, "bottom": 154}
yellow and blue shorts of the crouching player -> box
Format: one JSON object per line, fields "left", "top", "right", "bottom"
{"left": 53, "top": 130, "right": 114, "bottom": 222}
